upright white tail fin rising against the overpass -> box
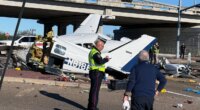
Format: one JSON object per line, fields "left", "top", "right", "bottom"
{"left": 74, "top": 14, "right": 101, "bottom": 34}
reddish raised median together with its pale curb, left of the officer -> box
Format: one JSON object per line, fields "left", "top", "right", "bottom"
{"left": 4, "top": 69, "right": 107, "bottom": 89}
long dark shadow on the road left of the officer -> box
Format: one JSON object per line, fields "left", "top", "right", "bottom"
{"left": 40, "top": 91, "right": 86, "bottom": 110}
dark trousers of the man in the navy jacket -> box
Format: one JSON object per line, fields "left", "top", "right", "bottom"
{"left": 131, "top": 97, "right": 154, "bottom": 110}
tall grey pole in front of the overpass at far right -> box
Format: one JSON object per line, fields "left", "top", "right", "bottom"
{"left": 176, "top": 0, "right": 182, "bottom": 59}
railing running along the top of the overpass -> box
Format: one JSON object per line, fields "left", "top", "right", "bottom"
{"left": 55, "top": 0, "right": 200, "bottom": 15}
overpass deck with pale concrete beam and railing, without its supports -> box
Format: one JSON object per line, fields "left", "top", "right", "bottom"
{"left": 0, "top": 0, "right": 200, "bottom": 26}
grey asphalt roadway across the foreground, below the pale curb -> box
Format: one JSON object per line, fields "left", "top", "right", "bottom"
{"left": 0, "top": 81, "right": 200, "bottom": 110}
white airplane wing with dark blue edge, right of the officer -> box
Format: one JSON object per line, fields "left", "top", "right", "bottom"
{"left": 107, "top": 35, "right": 156, "bottom": 73}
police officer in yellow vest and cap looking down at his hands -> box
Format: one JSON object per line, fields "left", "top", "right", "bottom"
{"left": 88, "top": 39, "right": 109, "bottom": 110}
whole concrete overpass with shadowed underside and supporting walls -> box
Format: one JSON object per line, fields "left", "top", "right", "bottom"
{"left": 0, "top": 0, "right": 200, "bottom": 55}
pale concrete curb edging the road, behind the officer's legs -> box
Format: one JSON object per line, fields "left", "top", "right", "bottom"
{"left": 4, "top": 77, "right": 108, "bottom": 89}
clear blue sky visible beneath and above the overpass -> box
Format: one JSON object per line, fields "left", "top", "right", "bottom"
{"left": 0, "top": 0, "right": 200, "bottom": 35}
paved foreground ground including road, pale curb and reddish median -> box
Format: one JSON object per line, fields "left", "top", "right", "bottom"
{"left": 0, "top": 55, "right": 200, "bottom": 110}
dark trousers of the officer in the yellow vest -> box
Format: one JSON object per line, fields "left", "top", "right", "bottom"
{"left": 88, "top": 71, "right": 104, "bottom": 110}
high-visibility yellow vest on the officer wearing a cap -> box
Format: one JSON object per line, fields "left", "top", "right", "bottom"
{"left": 88, "top": 48, "right": 105, "bottom": 72}
